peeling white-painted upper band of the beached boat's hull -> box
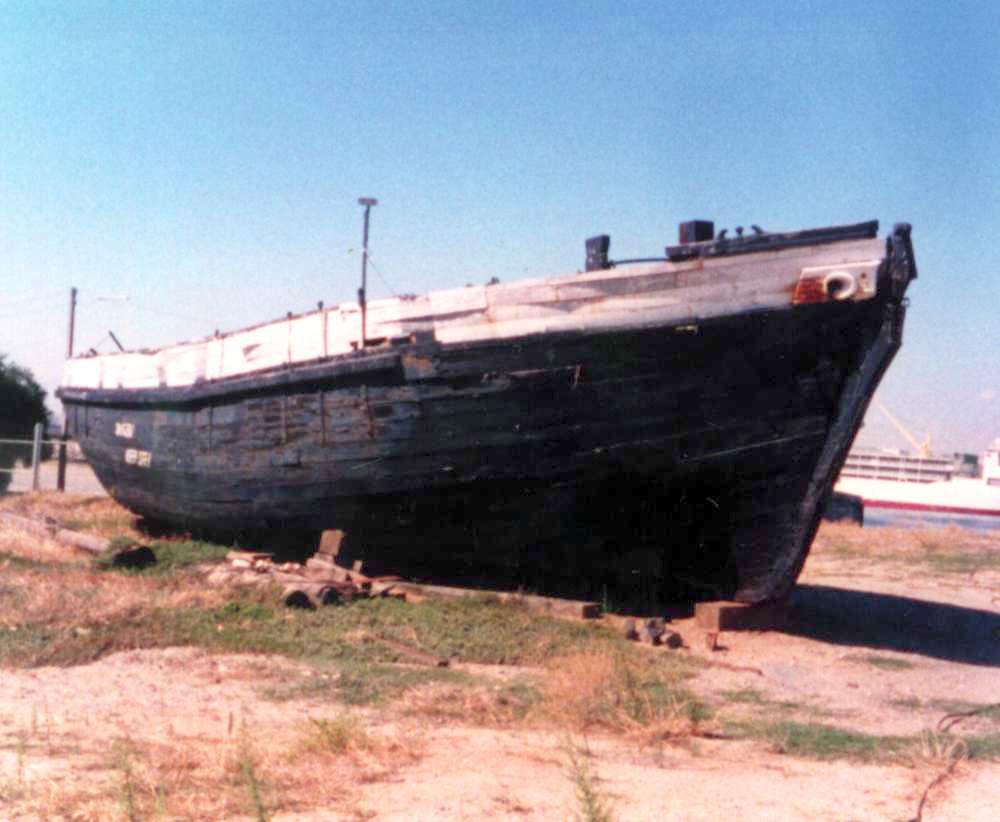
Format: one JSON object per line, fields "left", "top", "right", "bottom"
{"left": 62, "top": 238, "right": 885, "bottom": 390}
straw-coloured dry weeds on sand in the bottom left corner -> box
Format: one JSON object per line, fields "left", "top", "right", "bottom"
{"left": 0, "top": 717, "right": 422, "bottom": 822}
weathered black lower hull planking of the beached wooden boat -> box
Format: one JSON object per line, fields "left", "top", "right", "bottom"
{"left": 60, "top": 233, "right": 914, "bottom": 601}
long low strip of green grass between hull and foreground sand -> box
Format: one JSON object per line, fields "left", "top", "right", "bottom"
{"left": 0, "top": 592, "right": 648, "bottom": 715}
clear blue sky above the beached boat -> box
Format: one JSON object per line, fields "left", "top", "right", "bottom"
{"left": 0, "top": 0, "right": 1000, "bottom": 451}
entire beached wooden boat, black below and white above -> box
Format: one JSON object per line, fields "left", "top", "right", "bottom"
{"left": 59, "top": 223, "right": 916, "bottom": 602}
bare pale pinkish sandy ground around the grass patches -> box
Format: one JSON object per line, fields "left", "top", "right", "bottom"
{"left": 0, "top": 532, "right": 1000, "bottom": 822}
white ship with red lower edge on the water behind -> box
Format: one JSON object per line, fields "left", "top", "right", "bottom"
{"left": 834, "top": 438, "right": 1000, "bottom": 518}
